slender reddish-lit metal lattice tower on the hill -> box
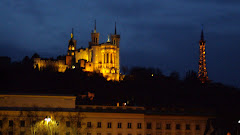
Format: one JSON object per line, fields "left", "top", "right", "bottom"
{"left": 198, "top": 26, "right": 208, "bottom": 83}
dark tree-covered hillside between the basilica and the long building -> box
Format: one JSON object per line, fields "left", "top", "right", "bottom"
{"left": 0, "top": 54, "right": 240, "bottom": 130}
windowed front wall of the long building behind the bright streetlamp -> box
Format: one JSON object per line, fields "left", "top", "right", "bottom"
{"left": 0, "top": 105, "right": 212, "bottom": 135}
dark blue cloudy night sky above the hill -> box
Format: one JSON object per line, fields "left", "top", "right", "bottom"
{"left": 0, "top": 0, "right": 240, "bottom": 87}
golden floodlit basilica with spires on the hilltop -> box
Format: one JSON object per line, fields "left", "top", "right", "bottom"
{"left": 34, "top": 21, "right": 120, "bottom": 81}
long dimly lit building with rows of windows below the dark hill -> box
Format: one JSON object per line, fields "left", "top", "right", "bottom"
{"left": 0, "top": 95, "right": 214, "bottom": 135}
